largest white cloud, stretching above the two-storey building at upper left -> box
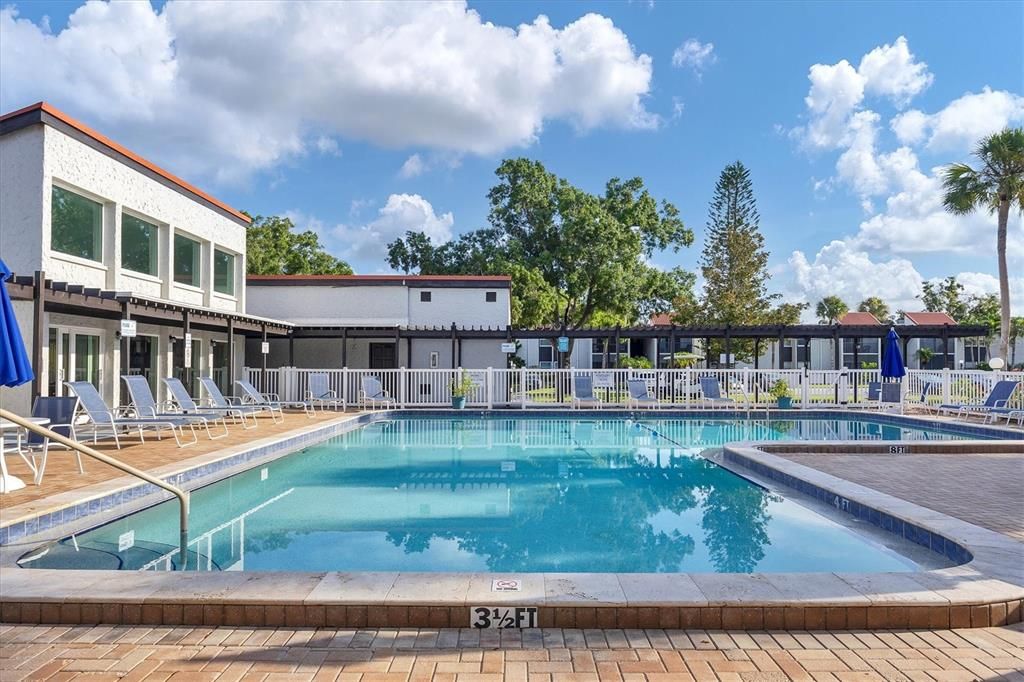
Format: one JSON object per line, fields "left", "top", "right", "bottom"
{"left": 0, "top": 0, "right": 659, "bottom": 179}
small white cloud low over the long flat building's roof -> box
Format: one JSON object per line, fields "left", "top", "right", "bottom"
{"left": 324, "top": 195, "right": 455, "bottom": 270}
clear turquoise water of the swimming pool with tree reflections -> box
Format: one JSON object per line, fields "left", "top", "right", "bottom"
{"left": 22, "top": 417, "right": 956, "bottom": 572}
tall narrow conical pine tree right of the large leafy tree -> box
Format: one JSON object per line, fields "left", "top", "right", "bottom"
{"left": 700, "top": 161, "right": 778, "bottom": 325}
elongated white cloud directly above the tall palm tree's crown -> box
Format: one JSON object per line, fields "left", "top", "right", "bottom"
{"left": 891, "top": 87, "right": 1024, "bottom": 151}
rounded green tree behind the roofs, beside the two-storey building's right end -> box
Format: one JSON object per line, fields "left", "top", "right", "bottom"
{"left": 246, "top": 215, "right": 352, "bottom": 274}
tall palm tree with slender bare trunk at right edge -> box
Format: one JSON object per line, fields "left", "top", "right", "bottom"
{"left": 942, "top": 128, "right": 1024, "bottom": 357}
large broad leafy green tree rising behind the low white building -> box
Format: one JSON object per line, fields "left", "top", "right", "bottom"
{"left": 388, "top": 159, "right": 693, "bottom": 358}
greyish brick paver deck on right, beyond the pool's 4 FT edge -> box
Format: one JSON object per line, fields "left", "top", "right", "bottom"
{"left": 776, "top": 444, "right": 1024, "bottom": 541}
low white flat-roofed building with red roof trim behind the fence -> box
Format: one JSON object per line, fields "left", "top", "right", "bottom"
{"left": 246, "top": 274, "right": 512, "bottom": 369}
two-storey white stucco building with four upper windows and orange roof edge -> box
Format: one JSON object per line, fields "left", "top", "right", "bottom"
{"left": 0, "top": 102, "right": 287, "bottom": 410}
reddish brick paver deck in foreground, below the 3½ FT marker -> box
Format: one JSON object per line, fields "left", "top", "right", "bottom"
{"left": 0, "top": 626, "right": 1024, "bottom": 682}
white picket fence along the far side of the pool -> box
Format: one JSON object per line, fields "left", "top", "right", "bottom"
{"left": 245, "top": 367, "right": 1024, "bottom": 409}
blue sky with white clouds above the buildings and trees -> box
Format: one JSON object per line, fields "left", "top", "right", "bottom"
{"left": 0, "top": 0, "right": 1024, "bottom": 314}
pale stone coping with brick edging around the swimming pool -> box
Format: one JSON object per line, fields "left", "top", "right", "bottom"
{"left": 0, "top": 410, "right": 1024, "bottom": 630}
